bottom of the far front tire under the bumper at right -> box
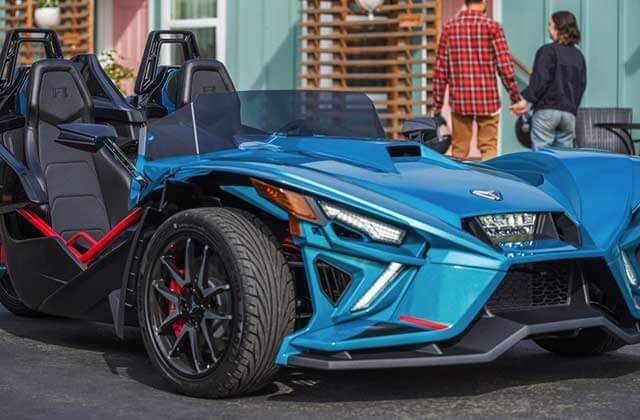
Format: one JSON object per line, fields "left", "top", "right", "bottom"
{"left": 534, "top": 328, "right": 625, "bottom": 357}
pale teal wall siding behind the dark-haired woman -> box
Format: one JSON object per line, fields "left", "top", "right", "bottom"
{"left": 502, "top": 0, "right": 640, "bottom": 153}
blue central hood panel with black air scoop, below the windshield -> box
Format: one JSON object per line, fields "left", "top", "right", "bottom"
{"left": 276, "top": 140, "right": 563, "bottom": 218}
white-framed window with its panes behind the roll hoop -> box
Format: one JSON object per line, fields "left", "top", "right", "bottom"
{"left": 162, "top": 0, "right": 226, "bottom": 62}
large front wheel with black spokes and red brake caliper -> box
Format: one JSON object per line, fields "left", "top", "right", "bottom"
{"left": 137, "top": 208, "right": 295, "bottom": 398}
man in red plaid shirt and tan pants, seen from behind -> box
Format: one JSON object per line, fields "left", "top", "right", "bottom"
{"left": 433, "top": 0, "right": 526, "bottom": 159}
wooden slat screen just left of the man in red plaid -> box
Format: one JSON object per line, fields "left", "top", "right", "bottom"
{"left": 299, "top": 0, "right": 440, "bottom": 138}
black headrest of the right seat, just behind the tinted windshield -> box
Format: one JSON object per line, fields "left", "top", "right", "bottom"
{"left": 176, "top": 58, "right": 236, "bottom": 108}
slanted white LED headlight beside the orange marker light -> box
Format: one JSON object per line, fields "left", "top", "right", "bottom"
{"left": 319, "top": 201, "right": 406, "bottom": 245}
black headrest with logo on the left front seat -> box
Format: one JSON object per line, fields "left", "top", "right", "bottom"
{"left": 27, "top": 59, "right": 93, "bottom": 124}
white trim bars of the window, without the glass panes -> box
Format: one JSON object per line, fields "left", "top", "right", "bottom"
{"left": 160, "top": 0, "right": 227, "bottom": 62}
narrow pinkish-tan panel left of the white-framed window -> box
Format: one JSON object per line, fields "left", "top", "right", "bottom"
{"left": 113, "top": 0, "right": 149, "bottom": 95}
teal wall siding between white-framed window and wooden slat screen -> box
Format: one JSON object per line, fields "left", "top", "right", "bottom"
{"left": 226, "top": 0, "right": 299, "bottom": 90}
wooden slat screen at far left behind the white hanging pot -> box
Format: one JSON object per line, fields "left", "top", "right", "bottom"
{"left": 0, "top": 0, "right": 94, "bottom": 64}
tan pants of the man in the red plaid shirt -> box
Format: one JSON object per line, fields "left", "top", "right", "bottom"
{"left": 451, "top": 112, "right": 500, "bottom": 160}
